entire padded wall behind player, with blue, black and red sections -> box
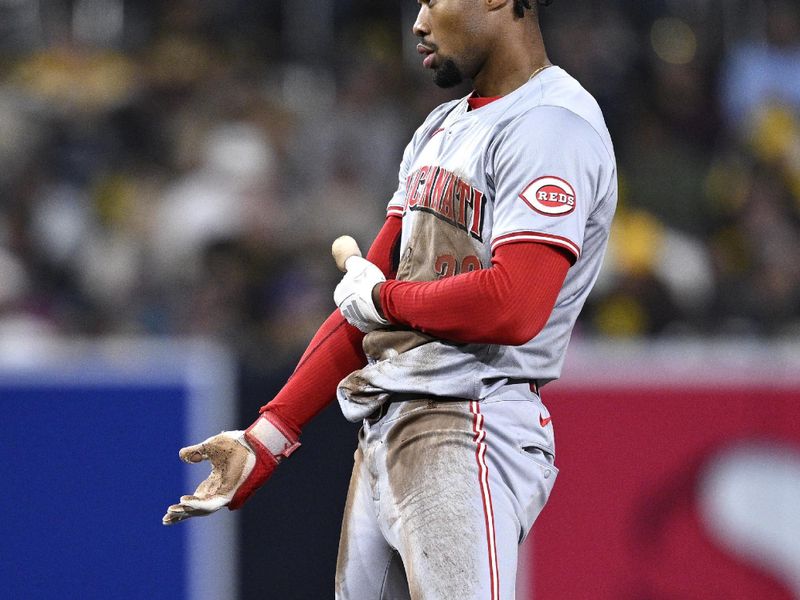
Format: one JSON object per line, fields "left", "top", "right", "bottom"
{"left": 0, "top": 340, "right": 800, "bottom": 600}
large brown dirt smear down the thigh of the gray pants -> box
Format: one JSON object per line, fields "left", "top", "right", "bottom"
{"left": 386, "top": 399, "right": 488, "bottom": 599}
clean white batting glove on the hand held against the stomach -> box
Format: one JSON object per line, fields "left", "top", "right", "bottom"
{"left": 333, "top": 256, "right": 389, "bottom": 333}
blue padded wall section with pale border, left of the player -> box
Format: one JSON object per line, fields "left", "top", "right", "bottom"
{"left": 0, "top": 339, "right": 238, "bottom": 600}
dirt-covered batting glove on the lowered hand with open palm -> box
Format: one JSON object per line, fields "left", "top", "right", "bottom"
{"left": 161, "top": 411, "right": 300, "bottom": 525}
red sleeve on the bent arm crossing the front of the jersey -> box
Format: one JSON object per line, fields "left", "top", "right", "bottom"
{"left": 380, "top": 242, "right": 574, "bottom": 346}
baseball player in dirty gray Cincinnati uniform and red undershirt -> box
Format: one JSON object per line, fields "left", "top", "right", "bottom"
{"left": 164, "top": 0, "right": 617, "bottom": 600}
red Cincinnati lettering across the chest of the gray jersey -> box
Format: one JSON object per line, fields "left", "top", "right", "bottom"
{"left": 406, "top": 166, "right": 484, "bottom": 241}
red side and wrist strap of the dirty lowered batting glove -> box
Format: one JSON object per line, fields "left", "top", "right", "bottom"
{"left": 228, "top": 412, "right": 300, "bottom": 510}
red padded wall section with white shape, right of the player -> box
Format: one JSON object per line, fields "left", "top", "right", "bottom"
{"left": 518, "top": 341, "right": 800, "bottom": 600}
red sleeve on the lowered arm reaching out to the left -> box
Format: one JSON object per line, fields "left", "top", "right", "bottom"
{"left": 261, "top": 216, "right": 402, "bottom": 435}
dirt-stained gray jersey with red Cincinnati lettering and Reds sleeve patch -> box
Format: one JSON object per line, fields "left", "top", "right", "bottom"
{"left": 337, "top": 66, "right": 617, "bottom": 421}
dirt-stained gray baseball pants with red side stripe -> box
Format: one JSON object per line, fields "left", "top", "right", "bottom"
{"left": 335, "top": 384, "right": 558, "bottom": 600}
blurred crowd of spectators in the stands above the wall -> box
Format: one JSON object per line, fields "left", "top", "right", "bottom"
{"left": 0, "top": 0, "right": 800, "bottom": 380}
